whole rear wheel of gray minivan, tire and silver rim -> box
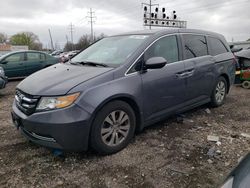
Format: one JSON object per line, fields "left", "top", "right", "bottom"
{"left": 211, "top": 76, "right": 228, "bottom": 107}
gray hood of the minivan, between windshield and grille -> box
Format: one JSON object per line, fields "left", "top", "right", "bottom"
{"left": 17, "top": 64, "right": 113, "bottom": 96}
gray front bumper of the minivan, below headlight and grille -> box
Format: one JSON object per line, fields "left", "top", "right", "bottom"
{"left": 12, "top": 101, "right": 90, "bottom": 151}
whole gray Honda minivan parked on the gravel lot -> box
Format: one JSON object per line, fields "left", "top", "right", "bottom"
{"left": 12, "top": 29, "right": 235, "bottom": 154}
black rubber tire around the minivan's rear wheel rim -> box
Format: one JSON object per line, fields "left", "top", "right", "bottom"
{"left": 211, "top": 76, "right": 228, "bottom": 107}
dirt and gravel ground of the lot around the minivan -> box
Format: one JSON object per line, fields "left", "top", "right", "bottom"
{"left": 0, "top": 81, "right": 250, "bottom": 188}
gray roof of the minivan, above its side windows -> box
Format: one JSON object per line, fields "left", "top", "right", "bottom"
{"left": 113, "top": 28, "right": 222, "bottom": 38}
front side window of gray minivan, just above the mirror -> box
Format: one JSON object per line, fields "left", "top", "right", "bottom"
{"left": 144, "top": 35, "right": 179, "bottom": 63}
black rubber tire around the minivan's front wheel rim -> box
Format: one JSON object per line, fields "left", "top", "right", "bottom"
{"left": 90, "top": 101, "right": 136, "bottom": 155}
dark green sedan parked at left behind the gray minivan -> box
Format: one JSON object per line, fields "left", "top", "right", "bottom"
{"left": 0, "top": 50, "right": 59, "bottom": 78}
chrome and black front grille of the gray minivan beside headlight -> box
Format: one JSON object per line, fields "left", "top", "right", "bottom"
{"left": 15, "top": 90, "right": 39, "bottom": 115}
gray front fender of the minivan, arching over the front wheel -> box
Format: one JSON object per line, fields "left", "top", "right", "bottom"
{"left": 74, "top": 74, "right": 143, "bottom": 130}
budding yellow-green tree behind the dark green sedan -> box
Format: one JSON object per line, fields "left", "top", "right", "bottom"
{"left": 10, "top": 32, "right": 42, "bottom": 50}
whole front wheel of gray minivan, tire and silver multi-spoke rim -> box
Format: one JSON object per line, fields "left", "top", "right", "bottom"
{"left": 90, "top": 101, "right": 136, "bottom": 155}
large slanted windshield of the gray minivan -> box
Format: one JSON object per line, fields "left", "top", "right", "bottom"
{"left": 71, "top": 35, "right": 148, "bottom": 67}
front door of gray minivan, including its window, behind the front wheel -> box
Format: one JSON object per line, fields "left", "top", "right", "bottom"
{"left": 141, "top": 35, "right": 185, "bottom": 121}
